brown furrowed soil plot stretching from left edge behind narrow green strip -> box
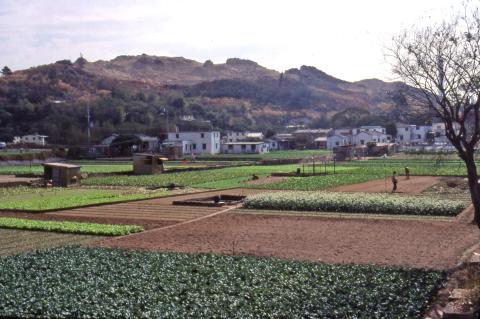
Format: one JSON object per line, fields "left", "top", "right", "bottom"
{"left": 0, "top": 189, "right": 265, "bottom": 229}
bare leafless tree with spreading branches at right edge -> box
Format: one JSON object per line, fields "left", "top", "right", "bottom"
{"left": 389, "top": 4, "right": 480, "bottom": 227}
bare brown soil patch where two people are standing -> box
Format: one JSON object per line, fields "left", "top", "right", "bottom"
{"left": 329, "top": 176, "right": 441, "bottom": 194}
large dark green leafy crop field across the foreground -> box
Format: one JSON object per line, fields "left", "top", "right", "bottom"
{"left": 0, "top": 247, "right": 445, "bottom": 319}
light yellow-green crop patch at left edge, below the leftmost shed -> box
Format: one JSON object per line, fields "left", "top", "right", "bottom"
{"left": 0, "top": 187, "right": 169, "bottom": 211}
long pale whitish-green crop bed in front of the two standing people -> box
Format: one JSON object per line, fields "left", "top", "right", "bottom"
{"left": 244, "top": 191, "right": 466, "bottom": 216}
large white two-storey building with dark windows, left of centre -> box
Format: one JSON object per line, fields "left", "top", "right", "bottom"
{"left": 163, "top": 131, "right": 220, "bottom": 155}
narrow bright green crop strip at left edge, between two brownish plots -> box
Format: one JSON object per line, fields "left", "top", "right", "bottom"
{"left": 0, "top": 217, "right": 143, "bottom": 236}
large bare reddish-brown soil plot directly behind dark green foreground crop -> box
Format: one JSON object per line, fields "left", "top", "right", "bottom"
{"left": 99, "top": 209, "right": 479, "bottom": 269}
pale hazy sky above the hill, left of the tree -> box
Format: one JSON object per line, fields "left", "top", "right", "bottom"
{"left": 0, "top": 0, "right": 461, "bottom": 81}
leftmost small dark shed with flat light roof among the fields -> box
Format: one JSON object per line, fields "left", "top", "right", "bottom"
{"left": 43, "top": 163, "right": 80, "bottom": 187}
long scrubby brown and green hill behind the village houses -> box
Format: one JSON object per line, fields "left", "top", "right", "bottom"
{"left": 0, "top": 54, "right": 428, "bottom": 144}
